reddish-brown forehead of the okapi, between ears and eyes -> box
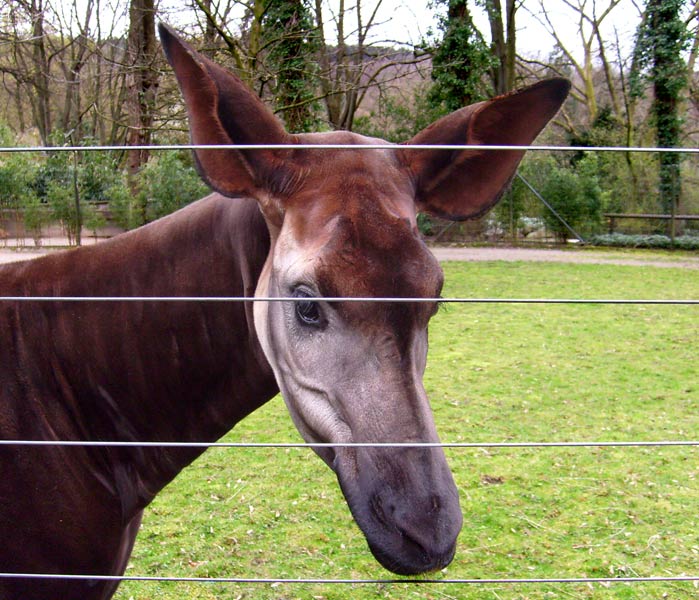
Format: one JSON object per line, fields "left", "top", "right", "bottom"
{"left": 278, "top": 132, "right": 442, "bottom": 297}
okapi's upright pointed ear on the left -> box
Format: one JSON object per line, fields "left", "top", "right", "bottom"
{"left": 158, "top": 23, "right": 293, "bottom": 223}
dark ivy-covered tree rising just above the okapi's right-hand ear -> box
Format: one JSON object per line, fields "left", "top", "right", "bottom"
{"left": 430, "top": 0, "right": 495, "bottom": 112}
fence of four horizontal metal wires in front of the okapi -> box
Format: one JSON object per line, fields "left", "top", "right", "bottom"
{"left": 0, "top": 144, "right": 699, "bottom": 586}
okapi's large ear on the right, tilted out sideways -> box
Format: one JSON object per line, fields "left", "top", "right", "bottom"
{"left": 399, "top": 78, "right": 570, "bottom": 221}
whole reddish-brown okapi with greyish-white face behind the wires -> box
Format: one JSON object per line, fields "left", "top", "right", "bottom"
{"left": 0, "top": 26, "right": 569, "bottom": 600}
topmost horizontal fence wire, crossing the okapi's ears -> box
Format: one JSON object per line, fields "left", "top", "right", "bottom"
{"left": 0, "top": 143, "right": 699, "bottom": 154}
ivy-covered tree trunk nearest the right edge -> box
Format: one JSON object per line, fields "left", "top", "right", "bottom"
{"left": 632, "top": 0, "right": 689, "bottom": 223}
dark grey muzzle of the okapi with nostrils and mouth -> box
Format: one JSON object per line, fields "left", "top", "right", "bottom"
{"left": 335, "top": 448, "right": 463, "bottom": 575}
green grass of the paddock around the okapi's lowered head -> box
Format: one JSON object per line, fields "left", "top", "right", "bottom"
{"left": 117, "top": 263, "right": 699, "bottom": 600}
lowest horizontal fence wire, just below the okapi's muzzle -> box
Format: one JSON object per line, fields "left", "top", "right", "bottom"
{"left": 0, "top": 573, "right": 699, "bottom": 585}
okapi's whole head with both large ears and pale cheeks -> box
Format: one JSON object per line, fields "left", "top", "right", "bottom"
{"left": 160, "top": 26, "right": 569, "bottom": 574}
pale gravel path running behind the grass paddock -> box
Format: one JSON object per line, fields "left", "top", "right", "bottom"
{"left": 0, "top": 247, "right": 699, "bottom": 269}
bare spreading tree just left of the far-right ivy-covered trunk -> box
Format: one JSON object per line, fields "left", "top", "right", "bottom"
{"left": 522, "top": 0, "right": 660, "bottom": 212}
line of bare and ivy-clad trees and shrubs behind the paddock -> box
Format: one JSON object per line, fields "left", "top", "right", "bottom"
{"left": 0, "top": 0, "right": 699, "bottom": 245}
